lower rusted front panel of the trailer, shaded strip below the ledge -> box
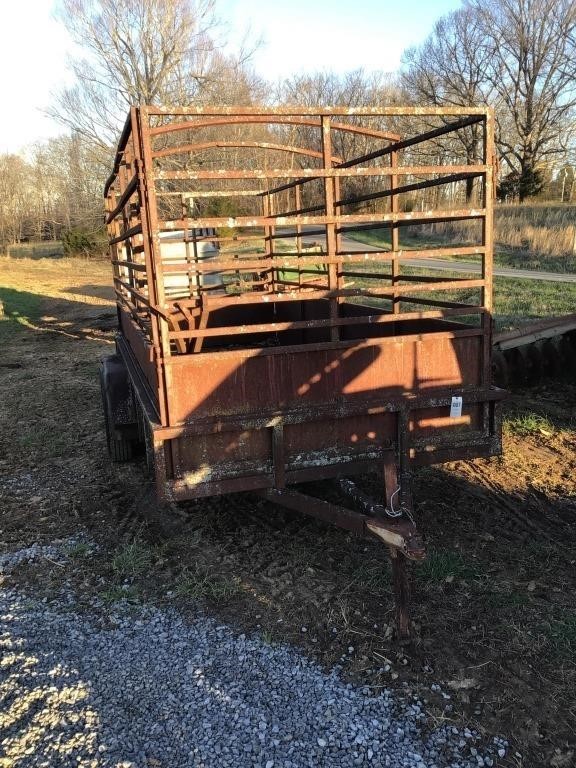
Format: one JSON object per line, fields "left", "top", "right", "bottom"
{"left": 160, "top": 402, "right": 501, "bottom": 499}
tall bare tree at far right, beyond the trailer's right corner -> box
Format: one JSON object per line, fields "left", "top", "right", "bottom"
{"left": 467, "top": 0, "right": 576, "bottom": 200}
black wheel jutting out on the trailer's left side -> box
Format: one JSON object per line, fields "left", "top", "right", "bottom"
{"left": 100, "top": 355, "right": 136, "bottom": 463}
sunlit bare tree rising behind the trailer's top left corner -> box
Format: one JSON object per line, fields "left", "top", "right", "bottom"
{"left": 51, "top": 0, "right": 254, "bottom": 154}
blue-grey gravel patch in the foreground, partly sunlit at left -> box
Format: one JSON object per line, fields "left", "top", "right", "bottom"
{"left": 0, "top": 568, "right": 507, "bottom": 768}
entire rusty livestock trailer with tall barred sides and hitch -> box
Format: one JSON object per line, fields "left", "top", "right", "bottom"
{"left": 101, "top": 107, "right": 502, "bottom": 636}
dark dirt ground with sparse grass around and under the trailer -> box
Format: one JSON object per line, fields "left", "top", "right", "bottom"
{"left": 0, "top": 259, "right": 576, "bottom": 768}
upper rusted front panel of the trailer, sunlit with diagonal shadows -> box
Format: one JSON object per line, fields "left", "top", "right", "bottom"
{"left": 165, "top": 334, "right": 481, "bottom": 426}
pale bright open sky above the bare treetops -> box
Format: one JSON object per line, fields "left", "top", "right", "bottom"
{"left": 0, "top": 0, "right": 461, "bottom": 153}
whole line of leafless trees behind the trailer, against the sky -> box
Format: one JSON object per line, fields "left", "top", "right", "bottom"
{"left": 0, "top": 0, "right": 576, "bottom": 252}
